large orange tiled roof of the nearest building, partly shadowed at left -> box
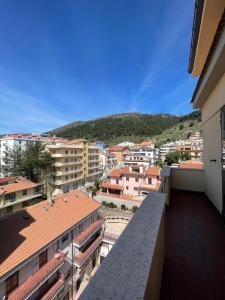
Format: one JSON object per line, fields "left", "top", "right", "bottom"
{"left": 0, "top": 190, "right": 101, "bottom": 278}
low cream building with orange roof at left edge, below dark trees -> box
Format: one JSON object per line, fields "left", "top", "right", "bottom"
{"left": 0, "top": 176, "right": 42, "bottom": 217}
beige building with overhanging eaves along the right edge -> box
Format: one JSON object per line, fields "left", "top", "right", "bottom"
{"left": 189, "top": 0, "right": 225, "bottom": 215}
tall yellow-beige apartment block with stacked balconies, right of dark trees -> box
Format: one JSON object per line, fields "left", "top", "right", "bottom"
{"left": 46, "top": 139, "right": 101, "bottom": 195}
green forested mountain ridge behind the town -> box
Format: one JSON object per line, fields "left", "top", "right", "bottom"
{"left": 48, "top": 111, "right": 201, "bottom": 144}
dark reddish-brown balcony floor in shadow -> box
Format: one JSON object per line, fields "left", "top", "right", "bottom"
{"left": 160, "top": 190, "right": 225, "bottom": 300}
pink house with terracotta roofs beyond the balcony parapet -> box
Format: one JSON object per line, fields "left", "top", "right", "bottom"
{"left": 101, "top": 165, "right": 161, "bottom": 196}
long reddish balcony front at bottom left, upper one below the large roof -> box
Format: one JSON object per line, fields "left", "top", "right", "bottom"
{"left": 8, "top": 253, "right": 64, "bottom": 300}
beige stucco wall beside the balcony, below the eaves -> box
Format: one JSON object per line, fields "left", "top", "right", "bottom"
{"left": 201, "top": 75, "right": 225, "bottom": 213}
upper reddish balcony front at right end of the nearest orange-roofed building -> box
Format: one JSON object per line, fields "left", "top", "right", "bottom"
{"left": 74, "top": 218, "right": 105, "bottom": 247}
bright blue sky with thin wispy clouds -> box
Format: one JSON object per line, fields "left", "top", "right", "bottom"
{"left": 0, "top": 0, "right": 196, "bottom": 133}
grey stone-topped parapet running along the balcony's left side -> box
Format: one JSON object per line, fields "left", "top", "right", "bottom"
{"left": 80, "top": 193, "right": 166, "bottom": 300}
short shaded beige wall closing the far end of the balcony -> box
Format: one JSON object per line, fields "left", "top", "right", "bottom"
{"left": 170, "top": 168, "right": 205, "bottom": 192}
